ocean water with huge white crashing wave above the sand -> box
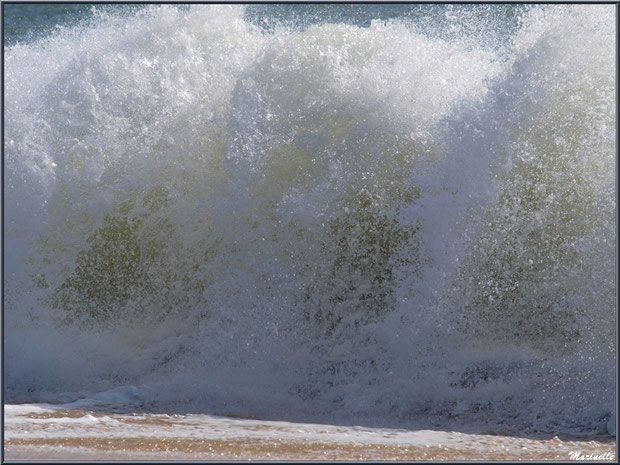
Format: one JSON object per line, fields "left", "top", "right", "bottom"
{"left": 3, "top": 4, "right": 617, "bottom": 434}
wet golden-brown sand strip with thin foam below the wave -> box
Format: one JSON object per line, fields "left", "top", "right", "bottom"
{"left": 4, "top": 405, "right": 616, "bottom": 461}
